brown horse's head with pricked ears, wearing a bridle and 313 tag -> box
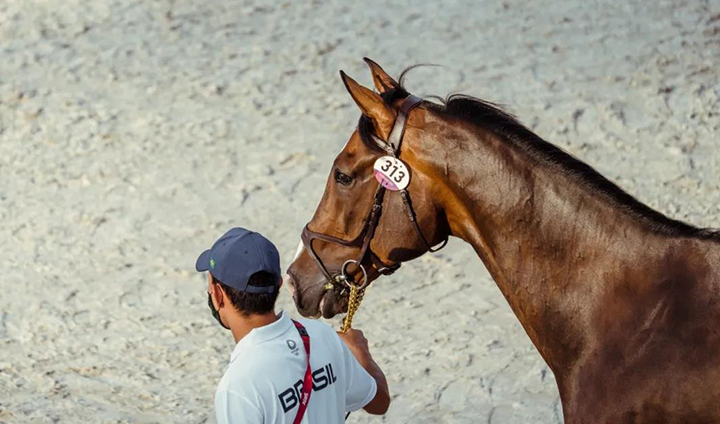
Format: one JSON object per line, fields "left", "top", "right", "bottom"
{"left": 286, "top": 58, "right": 449, "bottom": 318}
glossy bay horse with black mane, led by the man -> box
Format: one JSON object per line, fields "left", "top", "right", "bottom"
{"left": 286, "top": 59, "right": 720, "bottom": 424}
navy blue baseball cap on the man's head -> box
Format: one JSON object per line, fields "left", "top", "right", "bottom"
{"left": 195, "top": 228, "right": 281, "bottom": 293}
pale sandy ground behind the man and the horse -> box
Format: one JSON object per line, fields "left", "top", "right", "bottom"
{"left": 0, "top": 0, "right": 720, "bottom": 423}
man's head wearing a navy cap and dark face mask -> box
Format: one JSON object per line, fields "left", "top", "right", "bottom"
{"left": 195, "top": 228, "right": 282, "bottom": 328}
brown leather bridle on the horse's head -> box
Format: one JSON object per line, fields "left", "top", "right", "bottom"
{"left": 301, "top": 95, "right": 448, "bottom": 289}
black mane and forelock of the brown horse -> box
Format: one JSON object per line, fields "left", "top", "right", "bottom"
{"left": 358, "top": 65, "right": 720, "bottom": 241}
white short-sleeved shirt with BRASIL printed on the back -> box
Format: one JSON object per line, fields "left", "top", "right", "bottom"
{"left": 215, "top": 312, "right": 377, "bottom": 424}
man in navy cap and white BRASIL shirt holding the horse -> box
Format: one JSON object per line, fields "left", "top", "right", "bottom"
{"left": 195, "top": 228, "right": 390, "bottom": 424}
